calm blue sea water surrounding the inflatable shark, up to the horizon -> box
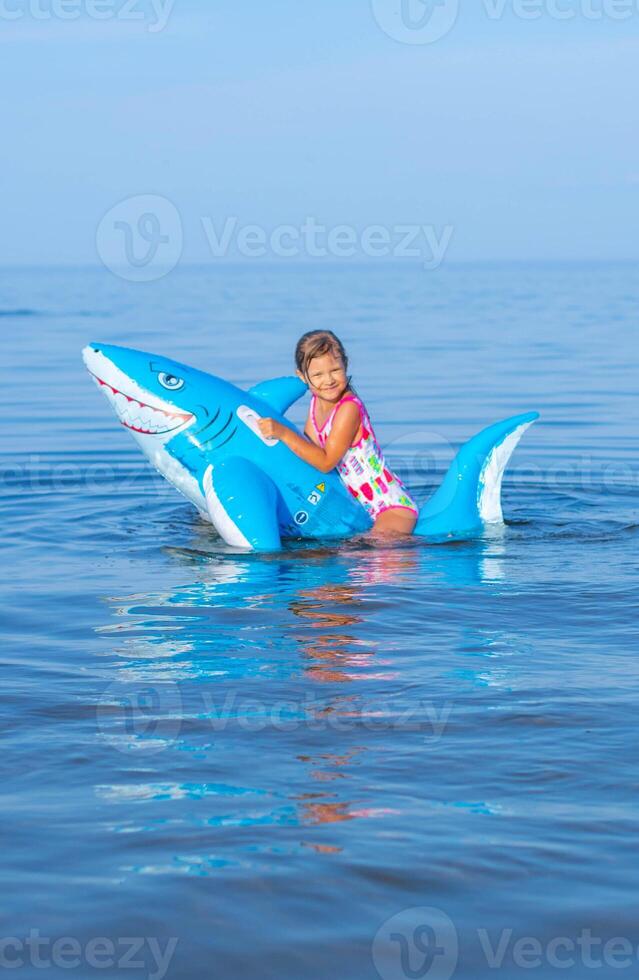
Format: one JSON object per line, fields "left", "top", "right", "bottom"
{"left": 0, "top": 264, "right": 639, "bottom": 980}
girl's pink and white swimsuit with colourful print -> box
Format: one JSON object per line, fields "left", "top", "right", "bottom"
{"left": 310, "top": 392, "right": 418, "bottom": 520}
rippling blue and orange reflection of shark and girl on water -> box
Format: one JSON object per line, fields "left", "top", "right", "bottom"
{"left": 96, "top": 535, "right": 528, "bottom": 874}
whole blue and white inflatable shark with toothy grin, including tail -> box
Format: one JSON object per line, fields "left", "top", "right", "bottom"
{"left": 83, "top": 344, "right": 538, "bottom": 551}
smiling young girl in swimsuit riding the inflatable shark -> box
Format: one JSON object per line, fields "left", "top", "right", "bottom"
{"left": 259, "top": 330, "right": 418, "bottom": 535}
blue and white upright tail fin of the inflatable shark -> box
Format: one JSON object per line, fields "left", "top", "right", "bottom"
{"left": 415, "top": 412, "right": 539, "bottom": 537}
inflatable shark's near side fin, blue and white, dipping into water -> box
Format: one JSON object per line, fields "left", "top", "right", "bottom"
{"left": 202, "top": 456, "right": 281, "bottom": 551}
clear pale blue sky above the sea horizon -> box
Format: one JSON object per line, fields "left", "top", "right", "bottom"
{"left": 0, "top": 0, "right": 639, "bottom": 264}
